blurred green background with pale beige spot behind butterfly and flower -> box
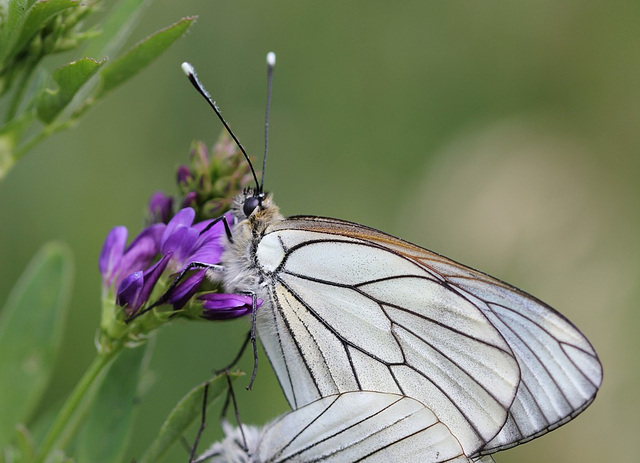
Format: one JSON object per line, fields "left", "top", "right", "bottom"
{"left": 0, "top": 0, "right": 640, "bottom": 463}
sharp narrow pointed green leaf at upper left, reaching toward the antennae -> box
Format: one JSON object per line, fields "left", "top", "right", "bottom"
{"left": 96, "top": 16, "right": 196, "bottom": 99}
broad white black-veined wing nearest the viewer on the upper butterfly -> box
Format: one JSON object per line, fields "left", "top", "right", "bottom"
{"left": 256, "top": 221, "right": 520, "bottom": 455}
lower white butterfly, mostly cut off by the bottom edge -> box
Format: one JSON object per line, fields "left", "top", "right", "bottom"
{"left": 196, "top": 392, "right": 493, "bottom": 463}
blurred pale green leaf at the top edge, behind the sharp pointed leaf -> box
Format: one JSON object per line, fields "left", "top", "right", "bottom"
{"left": 84, "top": 0, "right": 153, "bottom": 57}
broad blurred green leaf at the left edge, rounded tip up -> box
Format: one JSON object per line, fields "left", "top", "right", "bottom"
{"left": 0, "top": 243, "right": 73, "bottom": 447}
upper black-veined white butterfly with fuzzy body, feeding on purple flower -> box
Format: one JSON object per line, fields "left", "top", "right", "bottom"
{"left": 183, "top": 54, "right": 602, "bottom": 458}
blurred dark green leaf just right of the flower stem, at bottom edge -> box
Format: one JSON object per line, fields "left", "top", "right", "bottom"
{"left": 74, "top": 342, "right": 153, "bottom": 463}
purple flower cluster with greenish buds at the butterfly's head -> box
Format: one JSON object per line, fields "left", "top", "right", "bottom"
{"left": 98, "top": 137, "right": 262, "bottom": 338}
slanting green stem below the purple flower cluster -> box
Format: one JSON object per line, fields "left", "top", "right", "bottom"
{"left": 35, "top": 344, "right": 123, "bottom": 463}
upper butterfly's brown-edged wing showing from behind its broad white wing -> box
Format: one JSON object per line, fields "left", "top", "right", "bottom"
{"left": 276, "top": 217, "right": 602, "bottom": 454}
